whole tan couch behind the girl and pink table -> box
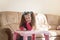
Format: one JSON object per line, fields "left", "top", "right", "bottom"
{"left": 0, "top": 11, "right": 60, "bottom": 40}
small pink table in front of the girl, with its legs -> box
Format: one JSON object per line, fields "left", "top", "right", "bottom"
{"left": 13, "top": 31, "right": 49, "bottom": 40}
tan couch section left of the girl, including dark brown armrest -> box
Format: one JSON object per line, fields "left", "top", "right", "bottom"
{"left": 0, "top": 11, "right": 21, "bottom": 40}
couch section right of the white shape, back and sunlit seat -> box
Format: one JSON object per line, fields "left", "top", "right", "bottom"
{"left": 45, "top": 14, "right": 60, "bottom": 40}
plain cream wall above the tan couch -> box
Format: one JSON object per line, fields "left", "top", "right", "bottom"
{"left": 0, "top": 0, "right": 60, "bottom": 15}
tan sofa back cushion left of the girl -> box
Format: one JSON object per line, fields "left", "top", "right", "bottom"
{"left": 0, "top": 12, "right": 21, "bottom": 25}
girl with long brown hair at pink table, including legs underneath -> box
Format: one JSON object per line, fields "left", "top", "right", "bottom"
{"left": 17, "top": 12, "right": 35, "bottom": 40}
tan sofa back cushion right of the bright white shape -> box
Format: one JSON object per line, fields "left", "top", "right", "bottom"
{"left": 45, "top": 14, "right": 59, "bottom": 25}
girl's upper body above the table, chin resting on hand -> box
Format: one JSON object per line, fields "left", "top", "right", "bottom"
{"left": 20, "top": 12, "right": 35, "bottom": 31}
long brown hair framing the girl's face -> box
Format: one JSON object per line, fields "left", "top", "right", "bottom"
{"left": 19, "top": 12, "right": 35, "bottom": 27}
